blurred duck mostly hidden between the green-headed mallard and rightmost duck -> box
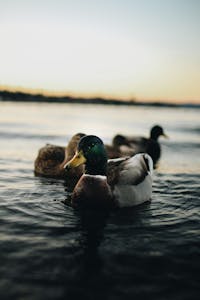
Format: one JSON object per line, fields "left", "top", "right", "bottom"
{"left": 105, "top": 134, "right": 135, "bottom": 158}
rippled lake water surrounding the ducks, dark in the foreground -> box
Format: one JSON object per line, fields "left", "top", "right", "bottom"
{"left": 0, "top": 102, "right": 200, "bottom": 300}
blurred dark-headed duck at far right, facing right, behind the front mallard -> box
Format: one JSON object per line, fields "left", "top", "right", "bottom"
{"left": 114, "top": 125, "right": 167, "bottom": 168}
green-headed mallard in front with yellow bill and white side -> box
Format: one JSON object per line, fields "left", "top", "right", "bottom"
{"left": 65, "top": 135, "right": 153, "bottom": 208}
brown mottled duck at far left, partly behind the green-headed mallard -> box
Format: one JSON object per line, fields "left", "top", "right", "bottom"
{"left": 34, "top": 133, "right": 85, "bottom": 179}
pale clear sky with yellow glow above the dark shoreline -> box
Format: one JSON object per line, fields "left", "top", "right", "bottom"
{"left": 0, "top": 0, "right": 200, "bottom": 103}
